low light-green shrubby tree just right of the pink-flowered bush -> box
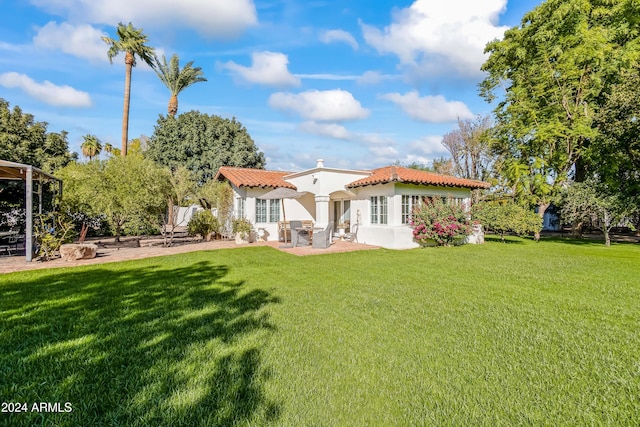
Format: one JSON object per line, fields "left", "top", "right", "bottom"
{"left": 472, "top": 201, "right": 542, "bottom": 242}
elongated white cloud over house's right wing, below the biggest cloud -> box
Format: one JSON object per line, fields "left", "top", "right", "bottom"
{"left": 382, "top": 91, "right": 474, "bottom": 123}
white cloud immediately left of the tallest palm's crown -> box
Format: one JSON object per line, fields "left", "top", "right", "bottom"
{"left": 33, "top": 21, "right": 108, "bottom": 61}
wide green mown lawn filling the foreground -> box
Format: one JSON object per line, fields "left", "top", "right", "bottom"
{"left": 0, "top": 239, "right": 640, "bottom": 426}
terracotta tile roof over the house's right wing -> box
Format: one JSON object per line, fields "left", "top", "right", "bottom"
{"left": 347, "top": 166, "right": 491, "bottom": 189}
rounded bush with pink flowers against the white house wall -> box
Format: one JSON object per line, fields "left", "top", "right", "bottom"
{"left": 410, "top": 198, "right": 471, "bottom": 246}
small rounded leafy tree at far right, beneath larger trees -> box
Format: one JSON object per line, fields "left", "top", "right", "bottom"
{"left": 560, "top": 180, "right": 634, "bottom": 246}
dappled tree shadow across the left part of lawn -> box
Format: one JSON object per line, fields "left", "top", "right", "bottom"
{"left": 0, "top": 262, "right": 279, "bottom": 426}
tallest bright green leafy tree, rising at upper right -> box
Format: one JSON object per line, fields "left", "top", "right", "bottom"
{"left": 480, "top": 0, "right": 640, "bottom": 239}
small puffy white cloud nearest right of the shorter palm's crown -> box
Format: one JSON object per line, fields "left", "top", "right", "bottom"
{"left": 222, "top": 52, "right": 300, "bottom": 88}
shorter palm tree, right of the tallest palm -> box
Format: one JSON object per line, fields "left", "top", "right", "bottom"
{"left": 154, "top": 53, "right": 207, "bottom": 117}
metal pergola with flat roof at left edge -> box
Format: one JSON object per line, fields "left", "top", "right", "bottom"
{"left": 0, "top": 160, "right": 62, "bottom": 262}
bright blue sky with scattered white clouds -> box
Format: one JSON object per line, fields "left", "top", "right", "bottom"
{"left": 0, "top": 0, "right": 542, "bottom": 171}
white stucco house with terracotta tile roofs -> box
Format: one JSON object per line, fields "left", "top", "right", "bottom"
{"left": 215, "top": 160, "right": 489, "bottom": 249}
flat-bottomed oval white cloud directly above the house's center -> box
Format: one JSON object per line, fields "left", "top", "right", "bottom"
{"left": 269, "top": 89, "right": 369, "bottom": 122}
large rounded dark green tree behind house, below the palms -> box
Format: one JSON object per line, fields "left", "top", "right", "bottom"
{"left": 145, "top": 111, "right": 265, "bottom": 185}
